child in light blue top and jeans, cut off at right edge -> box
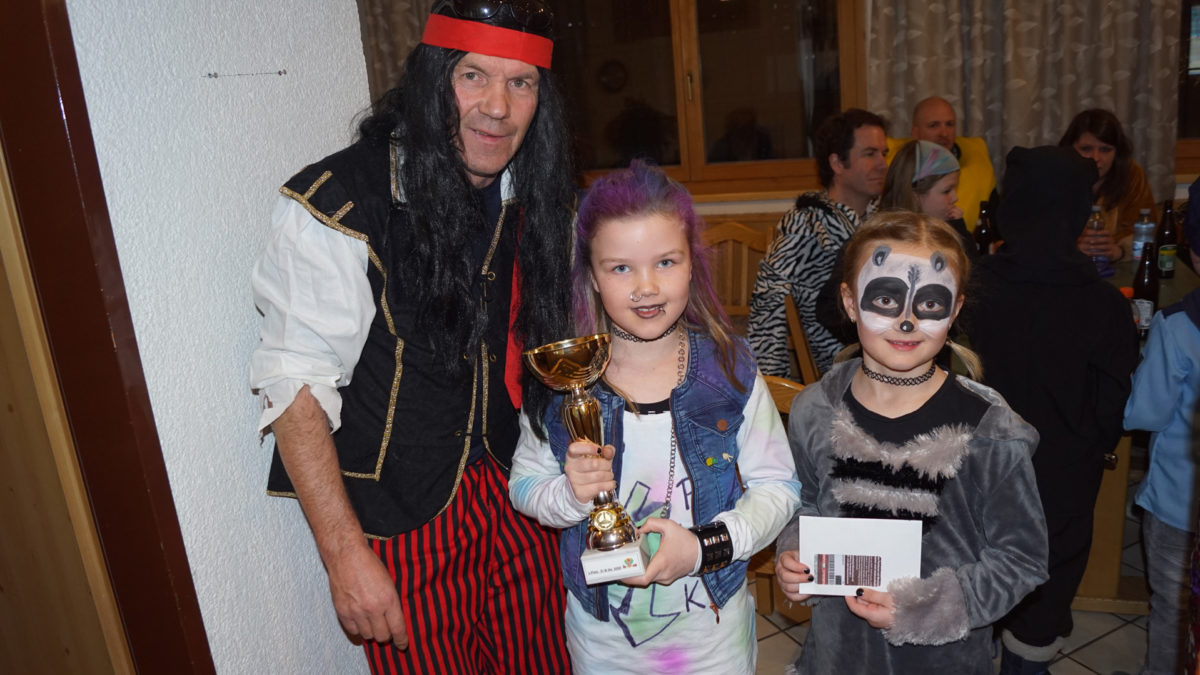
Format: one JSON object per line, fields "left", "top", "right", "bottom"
{"left": 1124, "top": 182, "right": 1200, "bottom": 675}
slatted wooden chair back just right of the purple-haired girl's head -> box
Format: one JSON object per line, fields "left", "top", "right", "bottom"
{"left": 703, "top": 221, "right": 772, "bottom": 335}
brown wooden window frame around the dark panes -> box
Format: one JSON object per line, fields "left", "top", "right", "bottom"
{"left": 584, "top": 0, "right": 866, "bottom": 201}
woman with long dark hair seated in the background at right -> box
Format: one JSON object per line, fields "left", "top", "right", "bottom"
{"left": 1058, "top": 108, "right": 1158, "bottom": 262}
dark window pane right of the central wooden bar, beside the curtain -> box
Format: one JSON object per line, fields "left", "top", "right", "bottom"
{"left": 700, "top": 0, "right": 841, "bottom": 163}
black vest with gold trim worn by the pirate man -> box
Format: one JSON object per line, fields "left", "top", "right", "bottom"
{"left": 268, "top": 141, "right": 520, "bottom": 538}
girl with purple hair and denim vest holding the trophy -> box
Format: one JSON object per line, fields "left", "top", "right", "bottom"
{"left": 509, "top": 161, "right": 800, "bottom": 674}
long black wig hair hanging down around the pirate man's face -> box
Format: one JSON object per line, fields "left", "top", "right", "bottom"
{"left": 359, "top": 44, "right": 575, "bottom": 435}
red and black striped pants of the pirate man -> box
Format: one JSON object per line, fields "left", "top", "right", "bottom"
{"left": 364, "top": 459, "right": 570, "bottom": 675}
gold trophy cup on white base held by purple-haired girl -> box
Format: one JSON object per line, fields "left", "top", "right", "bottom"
{"left": 524, "top": 333, "right": 647, "bottom": 584}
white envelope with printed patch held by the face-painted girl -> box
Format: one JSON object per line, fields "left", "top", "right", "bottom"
{"left": 799, "top": 515, "right": 920, "bottom": 596}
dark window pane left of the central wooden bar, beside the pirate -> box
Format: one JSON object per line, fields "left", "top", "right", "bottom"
{"left": 550, "top": 0, "right": 679, "bottom": 169}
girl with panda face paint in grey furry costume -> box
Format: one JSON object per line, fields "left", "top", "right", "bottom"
{"left": 775, "top": 211, "right": 1046, "bottom": 675}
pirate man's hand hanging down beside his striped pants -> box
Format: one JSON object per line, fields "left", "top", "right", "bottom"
{"left": 326, "top": 538, "right": 408, "bottom": 650}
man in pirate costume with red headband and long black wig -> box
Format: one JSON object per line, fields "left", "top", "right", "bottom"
{"left": 251, "top": 0, "right": 574, "bottom": 673}
